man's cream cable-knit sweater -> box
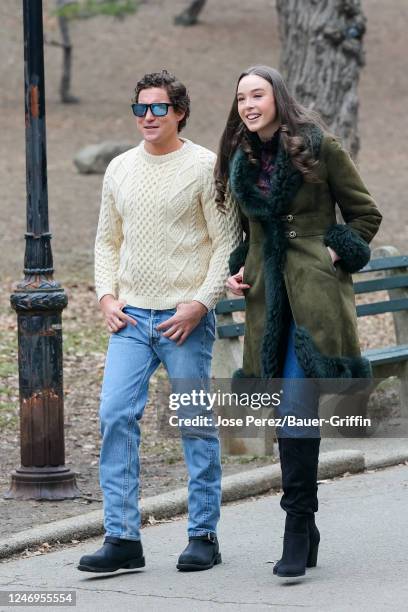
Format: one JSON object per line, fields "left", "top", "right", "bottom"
{"left": 95, "top": 139, "right": 241, "bottom": 310}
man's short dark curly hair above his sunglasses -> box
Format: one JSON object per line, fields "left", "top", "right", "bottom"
{"left": 134, "top": 70, "right": 190, "bottom": 132}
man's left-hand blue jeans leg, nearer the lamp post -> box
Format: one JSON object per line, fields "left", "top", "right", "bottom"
{"left": 99, "top": 316, "right": 160, "bottom": 540}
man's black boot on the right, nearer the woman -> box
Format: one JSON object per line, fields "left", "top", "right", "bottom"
{"left": 177, "top": 533, "right": 221, "bottom": 572}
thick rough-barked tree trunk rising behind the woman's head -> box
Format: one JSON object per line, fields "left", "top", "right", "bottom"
{"left": 276, "top": 0, "right": 366, "bottom": 158}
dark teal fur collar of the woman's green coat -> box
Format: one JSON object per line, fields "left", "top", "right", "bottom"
{"left": 230, "top": 126, "right": 323, "bottom": 221}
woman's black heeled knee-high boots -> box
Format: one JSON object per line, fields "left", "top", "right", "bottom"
{"left": 273, "top": 438, "right": 320, "bottom": 577}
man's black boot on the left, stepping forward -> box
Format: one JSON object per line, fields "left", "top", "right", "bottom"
{"left": 78, "top": 536, "right": 145, "bottom": 572}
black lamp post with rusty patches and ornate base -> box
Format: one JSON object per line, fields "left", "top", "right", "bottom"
{"left": 5, "top": 0, "right": 80, "bottom": 499}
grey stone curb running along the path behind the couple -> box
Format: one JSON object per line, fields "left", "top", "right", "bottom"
{"left": 0, "top": 450, "right": 400, "bottom": 559}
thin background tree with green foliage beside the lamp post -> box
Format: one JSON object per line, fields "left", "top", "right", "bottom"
{"left": 49, "top": 0, "right": 138, "bottom": 104}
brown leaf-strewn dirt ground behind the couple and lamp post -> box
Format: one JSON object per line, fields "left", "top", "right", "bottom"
{"left": 0, "top": 0, "right": 408, "bottom": 531}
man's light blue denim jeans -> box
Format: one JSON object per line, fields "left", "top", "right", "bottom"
{"left": 100, "top": 306, "right": 221, "bottom": 540}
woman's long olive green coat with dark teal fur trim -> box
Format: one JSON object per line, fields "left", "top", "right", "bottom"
{"left": 230, "top": 127, "right": 382, "bottom": 378}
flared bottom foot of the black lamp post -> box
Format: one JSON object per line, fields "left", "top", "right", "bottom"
{"left": 4, "top": 466, "right": 81, "bottom": 500}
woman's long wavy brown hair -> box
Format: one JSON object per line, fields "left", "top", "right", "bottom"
{"left": 214, "top": 66, "right": 328, "bottom": 210}
